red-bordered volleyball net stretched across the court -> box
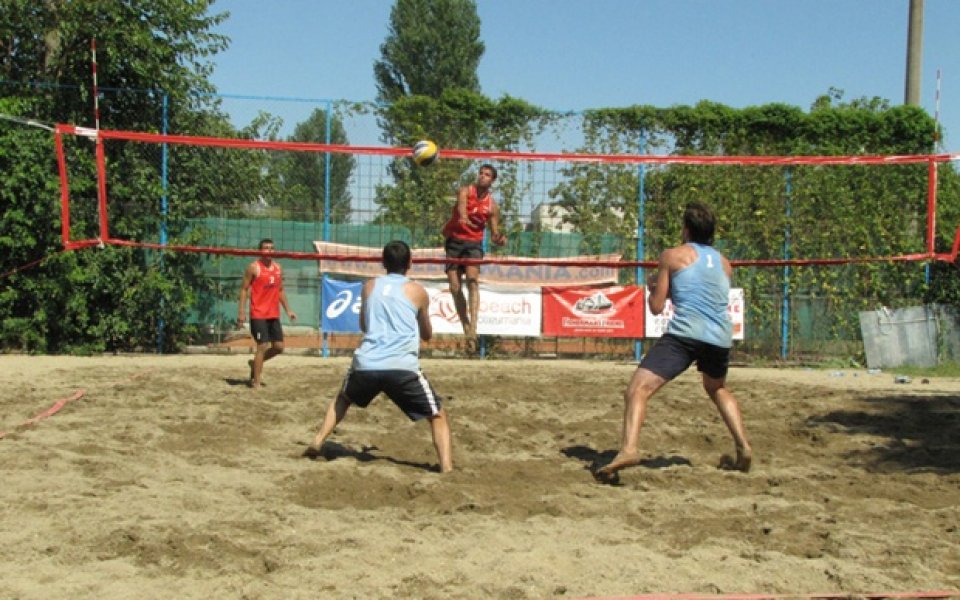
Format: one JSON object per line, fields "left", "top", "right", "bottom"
{"left": 55, "top": 125, "right": 960, "bottom": 268}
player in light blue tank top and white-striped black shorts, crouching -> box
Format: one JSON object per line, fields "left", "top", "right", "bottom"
{"left": 305, "top": 241, "right": 453, "bottom": 473}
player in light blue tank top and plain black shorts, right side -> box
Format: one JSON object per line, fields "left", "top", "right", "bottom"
{"left": 595, "top": 202, "right": 753, "bottom": 483}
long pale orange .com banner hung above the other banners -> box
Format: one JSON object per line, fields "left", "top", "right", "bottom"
{"left": 313, "top": 242, "right": 620, "bottom": 287}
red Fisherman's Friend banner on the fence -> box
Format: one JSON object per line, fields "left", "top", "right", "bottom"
{"left": 543, "top": 286, "right": 644, "bottom": 338}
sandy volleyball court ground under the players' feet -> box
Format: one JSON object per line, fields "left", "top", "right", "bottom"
{"left": 0, "top": 355, "right": 960, "bottom": 599}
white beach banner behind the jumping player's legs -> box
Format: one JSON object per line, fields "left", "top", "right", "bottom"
{"left": 419, "top": 281, "right": 542, "bottom": 337}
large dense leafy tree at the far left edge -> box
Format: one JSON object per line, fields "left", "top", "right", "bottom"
{"left": 0, "top": 0, "right": 232, "bottom": 352}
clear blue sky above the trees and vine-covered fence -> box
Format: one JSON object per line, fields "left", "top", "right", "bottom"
{"left": 213, "top": 0, "right": 960, "bottom": 152}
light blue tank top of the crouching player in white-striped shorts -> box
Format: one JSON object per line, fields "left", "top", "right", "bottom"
{"left": 353, "top": 273, "right": 420, "bottom": 371}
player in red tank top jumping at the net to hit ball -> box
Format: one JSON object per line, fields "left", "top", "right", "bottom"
{"left": 443, "top": 165, "right": 507, "bottom": 338}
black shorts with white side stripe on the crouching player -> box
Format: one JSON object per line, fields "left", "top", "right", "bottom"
{"left": 340, "top": 369, "right": 443, "bottom": 421}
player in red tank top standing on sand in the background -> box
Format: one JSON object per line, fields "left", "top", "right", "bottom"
{"left": 237, "top": 240, "right": 297, "bottom": 389}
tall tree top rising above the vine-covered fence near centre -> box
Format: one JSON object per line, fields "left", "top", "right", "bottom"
{"left": 373, "top": 0, "right": 484, "bottom": 103}
